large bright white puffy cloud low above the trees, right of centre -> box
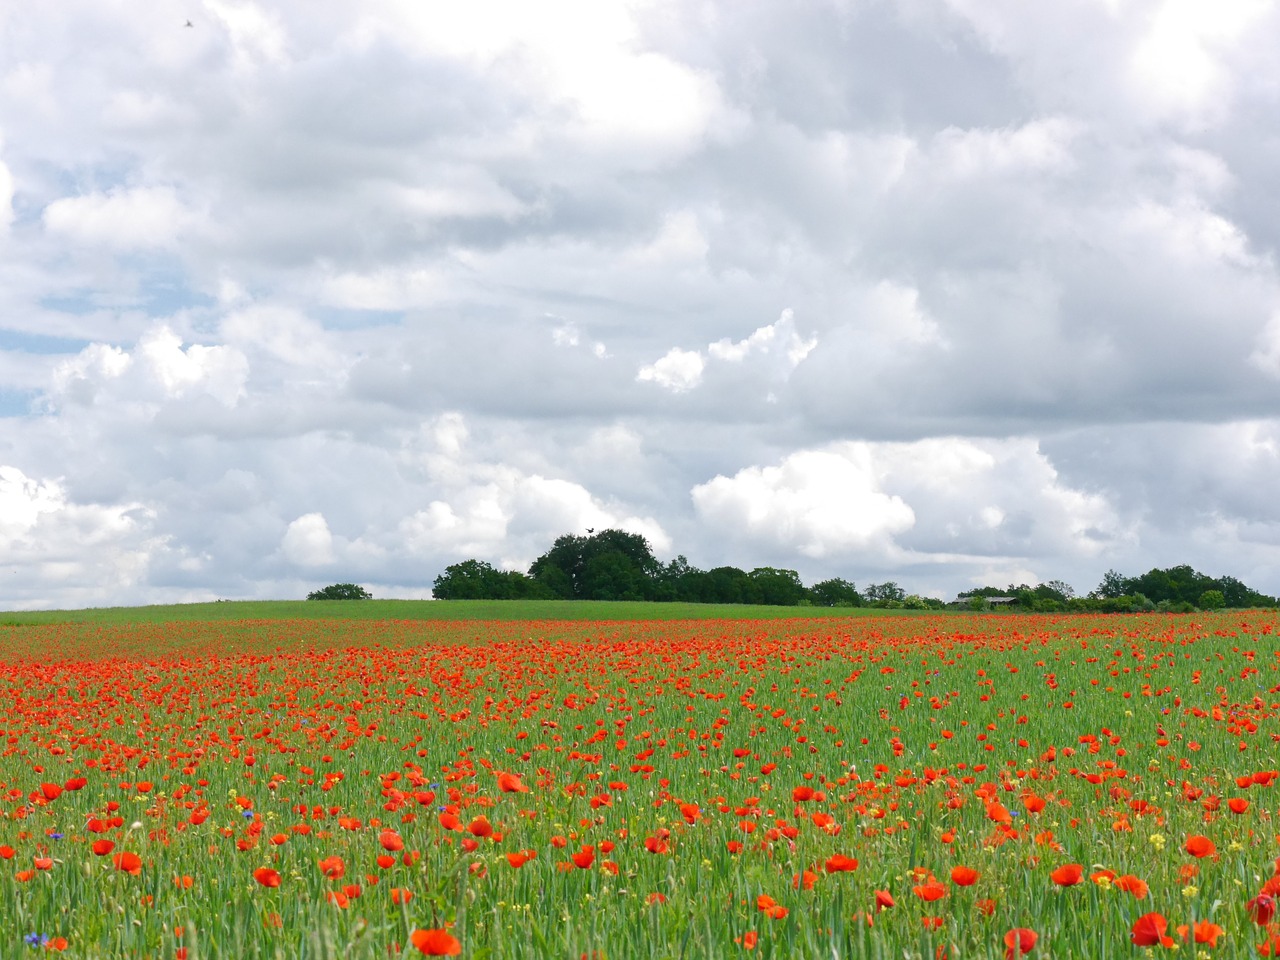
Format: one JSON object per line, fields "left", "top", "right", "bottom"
{"left": 691, "top": 438, "right": 1132, "bottom": 579}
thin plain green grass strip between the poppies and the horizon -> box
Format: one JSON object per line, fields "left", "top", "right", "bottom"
{"left": 0, "top": 600, "right": 906, "bottom": 626}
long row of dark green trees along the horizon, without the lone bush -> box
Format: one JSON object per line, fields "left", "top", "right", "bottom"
{"left": 433, "top": 530, "right": 1277, "bottom": 612}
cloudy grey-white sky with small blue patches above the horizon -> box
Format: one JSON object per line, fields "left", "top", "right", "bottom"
{"left": 0, "top": 0, "right": 1280, "bottom": 608}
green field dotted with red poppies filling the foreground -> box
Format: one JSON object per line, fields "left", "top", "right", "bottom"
{"left": 0, "top": 612, "right": 1280, "bottom": 960}
